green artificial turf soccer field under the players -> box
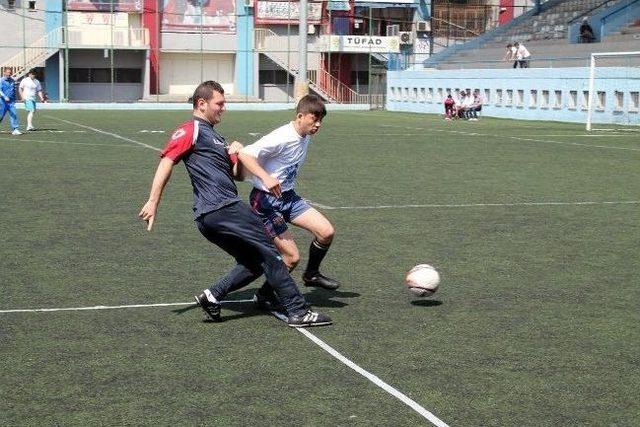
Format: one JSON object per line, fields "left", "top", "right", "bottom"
{"left": 0, "top": 111, "right": 640, "bottom": 426}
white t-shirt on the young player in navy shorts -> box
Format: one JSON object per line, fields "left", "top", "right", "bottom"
{"left": 242, "top": 122, "right": 311, "bottom": 191}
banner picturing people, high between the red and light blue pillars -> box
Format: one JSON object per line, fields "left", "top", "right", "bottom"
{"left": 162, "top": 0, "right": 236, "bottom": 34}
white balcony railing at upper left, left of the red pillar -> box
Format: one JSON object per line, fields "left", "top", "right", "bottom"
{"left": 66, "top": 26, "right": 149, "bottom": 49}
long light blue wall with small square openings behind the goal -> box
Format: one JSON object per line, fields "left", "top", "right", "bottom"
{"left": 387, "top": 67, "right": 640, "bottom": 125}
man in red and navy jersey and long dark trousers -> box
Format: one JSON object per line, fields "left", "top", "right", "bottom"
{"left": 139, "top": 81, "right": 331, "bottom": 327}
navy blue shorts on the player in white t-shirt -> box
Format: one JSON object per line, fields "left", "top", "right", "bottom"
{"left": 249, "top": 188, "right": 311, "bottom": 239}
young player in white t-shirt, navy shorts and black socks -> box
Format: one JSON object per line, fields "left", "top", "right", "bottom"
{"left": 238, "top": 95, "right": 340, "bottom": 307}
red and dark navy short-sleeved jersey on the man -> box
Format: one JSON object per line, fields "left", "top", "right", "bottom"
{"left": 160, "top": 117, "right": 240, "bottom": 218}
